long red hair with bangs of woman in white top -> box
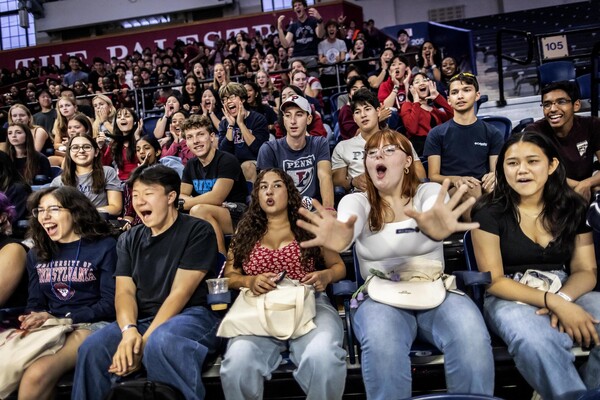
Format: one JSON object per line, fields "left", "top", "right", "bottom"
{"left": 364, "top": 128, "right": 421, "bottom": 232}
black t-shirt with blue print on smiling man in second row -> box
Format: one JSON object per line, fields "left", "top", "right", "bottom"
{"left": 181, "top": 150, "right": 248, "bottom": 203}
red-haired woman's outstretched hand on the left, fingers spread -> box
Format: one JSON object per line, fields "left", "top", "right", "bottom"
{"left": 297, "top": 199, "right": 356, "bottom": 252}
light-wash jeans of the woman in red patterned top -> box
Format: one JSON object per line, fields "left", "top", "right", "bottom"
{"left": 221, "top": 293, "right": 346, "bottom": 400}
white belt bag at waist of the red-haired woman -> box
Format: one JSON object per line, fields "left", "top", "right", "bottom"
{"left": 366, "top": 257, "right": 456, "bottom": 310}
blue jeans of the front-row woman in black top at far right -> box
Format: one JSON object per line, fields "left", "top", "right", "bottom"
{"left": 484, "top": 292, "right": 600, "bottom": 400}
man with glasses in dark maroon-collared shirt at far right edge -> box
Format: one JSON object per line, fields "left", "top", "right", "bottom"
{"left": 527, "top": 81, "right": 600, "bottom": 200}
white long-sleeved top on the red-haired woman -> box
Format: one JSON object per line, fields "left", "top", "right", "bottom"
{"left": 338, "top": 182, "right": 448, "bottom": 279}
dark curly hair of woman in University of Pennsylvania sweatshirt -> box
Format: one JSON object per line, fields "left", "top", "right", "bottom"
{"left": 27, "top": 186, "right": 116, "bottom": 261}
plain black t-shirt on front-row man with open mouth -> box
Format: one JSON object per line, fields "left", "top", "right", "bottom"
{"left": 115, "top": 214, "right": 217, "bottom": 318}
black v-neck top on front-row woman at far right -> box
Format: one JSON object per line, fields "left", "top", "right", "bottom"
{"left": 473, "top": 205, "right": 590, "bottom": 274}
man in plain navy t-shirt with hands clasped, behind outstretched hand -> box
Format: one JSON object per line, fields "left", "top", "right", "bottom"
{"left": 423, "top": 72, "right": 504, "bottom": 220}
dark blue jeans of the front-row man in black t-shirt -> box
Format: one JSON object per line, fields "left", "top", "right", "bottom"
{"left": 71, "top": 307, "right": 219, "bottom": 400}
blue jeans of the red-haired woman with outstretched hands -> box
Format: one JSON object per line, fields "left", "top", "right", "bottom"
{"left": 352, "top": 293, "right": 494, "bottom": 400}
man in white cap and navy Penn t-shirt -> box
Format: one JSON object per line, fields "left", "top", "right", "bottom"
{"left": 257, "top": 95, "right": 333, "bottom": 208}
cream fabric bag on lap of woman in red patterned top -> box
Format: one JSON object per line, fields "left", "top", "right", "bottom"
{"left": 217, "top": 278, "right": 316, "bottom": 340}
